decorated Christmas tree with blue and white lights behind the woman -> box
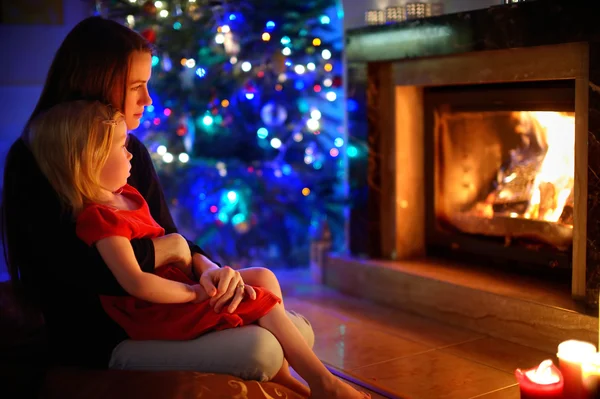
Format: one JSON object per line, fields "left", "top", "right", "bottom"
{"left": 95, "top": 0, "right": 359, "bottom": 268}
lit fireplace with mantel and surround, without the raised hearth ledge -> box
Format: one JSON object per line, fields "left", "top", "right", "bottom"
{"left": 346, "top": 8, "right": 600, "bottom": 306}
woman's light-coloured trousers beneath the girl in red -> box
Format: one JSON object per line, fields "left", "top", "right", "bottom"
{"left": 109, "top": 311, "right": 315, "bottom": 381}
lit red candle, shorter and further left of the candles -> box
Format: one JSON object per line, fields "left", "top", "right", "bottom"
{"left": 515, "top": 360, "right": 564, "bottom": 399}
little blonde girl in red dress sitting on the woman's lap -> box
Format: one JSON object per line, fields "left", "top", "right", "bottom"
{"left": 31, "top": 101, "right": 368, "bottom": 399}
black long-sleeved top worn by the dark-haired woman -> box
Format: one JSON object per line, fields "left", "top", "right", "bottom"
{"left": 3, "top": 135, "right": 217, "bottom": 368}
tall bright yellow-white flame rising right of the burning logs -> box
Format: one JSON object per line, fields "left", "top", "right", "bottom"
{"left": 520, "top": 112, "right": 575, "bottom": 222}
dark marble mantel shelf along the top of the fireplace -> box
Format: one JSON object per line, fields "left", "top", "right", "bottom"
{"left": 345, "top": 0, "right": 600, "bottom": 62}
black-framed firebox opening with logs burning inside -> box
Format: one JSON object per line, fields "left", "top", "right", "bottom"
{"left": 424, "top": 80, "right": 576, "bottom": 269}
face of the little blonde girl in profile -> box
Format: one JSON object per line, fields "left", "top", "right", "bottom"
{"left": 100, "top": 121, "right": 132, "bottom": 193}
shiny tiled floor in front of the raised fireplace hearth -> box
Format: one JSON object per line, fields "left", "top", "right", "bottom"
{"left": 278, "top": 272, "right": 556, "bottom": 399}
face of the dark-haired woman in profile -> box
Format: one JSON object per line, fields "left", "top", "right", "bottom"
{"left": 124, "top": 51, "right": 152, "bottom": 130}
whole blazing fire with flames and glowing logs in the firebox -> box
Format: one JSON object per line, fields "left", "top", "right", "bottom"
{"left": 472, "top": 111, "right": 575, "bottom": 225}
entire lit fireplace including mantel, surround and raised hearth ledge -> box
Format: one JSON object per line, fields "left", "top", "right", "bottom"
{"left": 332, "top": 0, "right": 600, "bottom": 351}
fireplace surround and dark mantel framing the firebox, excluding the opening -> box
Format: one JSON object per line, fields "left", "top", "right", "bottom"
{"left": 346, "top": 0, "right": 600, "bottom": 306}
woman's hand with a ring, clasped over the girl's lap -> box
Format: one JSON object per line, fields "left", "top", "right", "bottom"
{"left": 200, "top": 266, "right": 256, "bottom": 313}
